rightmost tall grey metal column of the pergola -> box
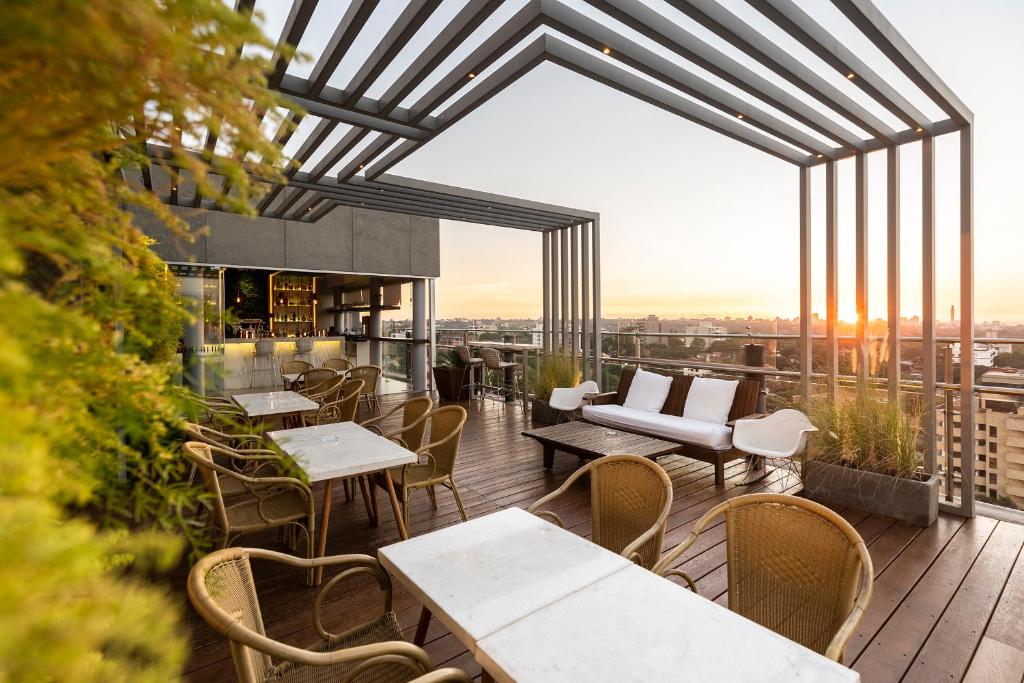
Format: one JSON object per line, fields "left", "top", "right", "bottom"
{"left": 958, "top": 126, "right": 976, "bottom": 517}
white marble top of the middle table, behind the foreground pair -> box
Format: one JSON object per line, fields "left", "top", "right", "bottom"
{"left": 267, "top": 422, "right": 416, "bottom": 482}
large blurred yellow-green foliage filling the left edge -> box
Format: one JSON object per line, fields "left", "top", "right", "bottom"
{"left": 0, "top": 0, "right": 294, "bottom": 681}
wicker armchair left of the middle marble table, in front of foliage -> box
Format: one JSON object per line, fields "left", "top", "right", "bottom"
{"left": 183, "top": 441, "right": 315, "bottom": 585}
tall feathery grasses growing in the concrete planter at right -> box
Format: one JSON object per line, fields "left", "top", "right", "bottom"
{"left": 808, "top": 391, "right": 921, "bottom": 477}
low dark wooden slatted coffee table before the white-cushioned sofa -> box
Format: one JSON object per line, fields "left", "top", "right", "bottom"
{"left": 522, "top": 421, "right": 682, "bottom": 470}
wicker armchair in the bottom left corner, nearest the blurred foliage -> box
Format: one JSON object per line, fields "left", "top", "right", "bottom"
{"left": 188, "top": 548, "right": 469, "bottom": 683}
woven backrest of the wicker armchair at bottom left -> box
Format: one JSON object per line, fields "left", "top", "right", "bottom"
{"left": 188, "top": 548, "right": 273, "bottom": 682}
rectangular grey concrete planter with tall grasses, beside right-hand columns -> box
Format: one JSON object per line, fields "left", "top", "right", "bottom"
{"left": 802, "top": 391, "right": 939, "bottom": 526}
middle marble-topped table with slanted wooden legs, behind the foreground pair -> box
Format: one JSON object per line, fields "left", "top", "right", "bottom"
{"left": 267, "top": 422, "right": 417, "bottom": 584}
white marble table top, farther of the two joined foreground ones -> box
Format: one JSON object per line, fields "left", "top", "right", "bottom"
{"left": 378, "top": 508, "right": 631, "bottom": 651}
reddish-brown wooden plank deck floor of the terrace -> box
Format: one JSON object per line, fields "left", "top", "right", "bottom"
{"left": 180, "top": 395, "right": 1024, "bottom": 683}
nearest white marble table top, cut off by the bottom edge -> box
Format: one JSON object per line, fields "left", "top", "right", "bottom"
{"left": 475, "top": 565, "right": 860, "bottom": 683}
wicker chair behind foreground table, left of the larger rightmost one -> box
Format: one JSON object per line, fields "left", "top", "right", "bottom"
{"left": 526, "top": 456, "right": 672, "bottom": 569}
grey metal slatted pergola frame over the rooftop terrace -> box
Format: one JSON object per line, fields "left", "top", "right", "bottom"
{"left": 140, "top": 0, "right": 975, "bottom": 514}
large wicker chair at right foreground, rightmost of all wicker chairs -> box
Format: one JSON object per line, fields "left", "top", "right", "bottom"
{"left": 654, "top": 494, "right": 874, "bottom": 663}
